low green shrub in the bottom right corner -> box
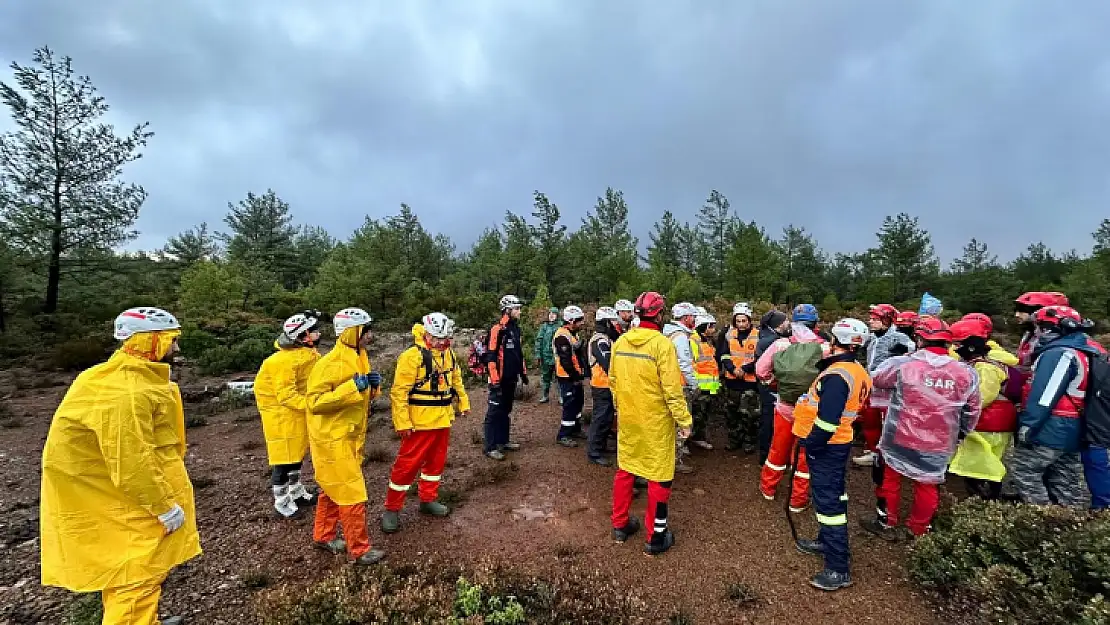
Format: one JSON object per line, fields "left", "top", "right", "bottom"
{"left": 908, "top": 498, "right": 1110, "bottom": 625}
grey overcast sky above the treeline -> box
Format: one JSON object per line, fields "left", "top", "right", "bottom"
{"left": 0, "top": 0, "right": 1110, "bottom": 261}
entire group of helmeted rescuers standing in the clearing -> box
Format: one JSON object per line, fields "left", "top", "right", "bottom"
{"left": 40, "top": 292, "right": 1110, "bottom": 625}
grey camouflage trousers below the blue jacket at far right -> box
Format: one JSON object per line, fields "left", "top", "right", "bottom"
{"left": 1010, "top": 445, "right": 1087, "bottom": 506}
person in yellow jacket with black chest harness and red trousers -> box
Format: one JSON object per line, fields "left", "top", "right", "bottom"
{"left": 382, "top": 312, "right": 471, "bottom": 534}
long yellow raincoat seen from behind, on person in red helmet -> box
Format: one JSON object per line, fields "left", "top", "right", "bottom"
{"left": 609, "top": 327, "right": 693, "bottom": 482}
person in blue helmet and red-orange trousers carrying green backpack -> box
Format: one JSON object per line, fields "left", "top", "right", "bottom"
{"left": 756, "top": 315, "right": 829, "bottom": 513}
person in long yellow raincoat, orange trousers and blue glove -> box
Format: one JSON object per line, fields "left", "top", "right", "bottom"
{"left": 307, "top": 308, "right": 385, "bottom": 565}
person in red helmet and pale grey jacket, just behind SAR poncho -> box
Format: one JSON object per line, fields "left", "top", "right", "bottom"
{"left": 851, "top": 304, "right": 916, "bottom": 470}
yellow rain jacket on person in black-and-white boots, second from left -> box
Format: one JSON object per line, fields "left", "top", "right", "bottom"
{"left": 254, "top": 343, "right": 319, "bottom": 466}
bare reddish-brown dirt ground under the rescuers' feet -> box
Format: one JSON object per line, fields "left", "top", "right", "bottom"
{"left": 0, "top": 357, "right": 939, "bottom": 625}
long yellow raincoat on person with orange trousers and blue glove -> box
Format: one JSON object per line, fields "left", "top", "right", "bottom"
{"left": 309, "top": 327, "right": 379, "bottom": 505}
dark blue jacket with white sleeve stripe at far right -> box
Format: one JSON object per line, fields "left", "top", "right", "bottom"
{"left": 1018, "top": 332, "right": 1098, "bottom": 452}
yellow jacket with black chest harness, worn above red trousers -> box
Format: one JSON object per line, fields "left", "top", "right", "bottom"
{"left": 390, "top": 323, "right": 471, "bottom": 432}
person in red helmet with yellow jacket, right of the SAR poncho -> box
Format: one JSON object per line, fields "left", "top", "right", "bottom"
{"left": 948, "top": 317, "right": 1018, "bottom": 500}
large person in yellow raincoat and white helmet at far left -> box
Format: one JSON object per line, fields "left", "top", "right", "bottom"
{"left": 40, "top": 308, "right": 201, "bottom": 625}
